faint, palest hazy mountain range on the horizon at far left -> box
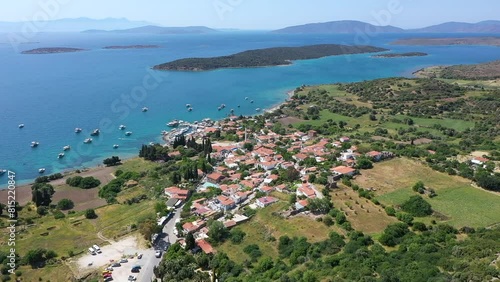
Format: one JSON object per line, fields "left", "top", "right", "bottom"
{"left": 0, "top": 18, "right": 152, "bottom": 32}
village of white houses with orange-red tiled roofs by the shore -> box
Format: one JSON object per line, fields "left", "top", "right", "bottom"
{"left": 153, "top": 106, "right": 394, "bottom": 254}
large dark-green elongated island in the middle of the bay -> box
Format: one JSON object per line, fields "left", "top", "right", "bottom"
{"left": 153, "top": 44, "right": 388, "bottom": 71}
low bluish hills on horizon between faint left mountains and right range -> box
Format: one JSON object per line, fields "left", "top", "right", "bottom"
{"left": 84, "top": 25, "right": 217, "bottom": 34}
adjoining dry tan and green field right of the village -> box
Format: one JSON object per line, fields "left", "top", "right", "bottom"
{"left": 355, "top": 158, "right": 500, "bottom": 227}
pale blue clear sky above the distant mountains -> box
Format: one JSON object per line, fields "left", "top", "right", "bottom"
{"left": 0, "top": 0, "right": 500, "bottom": 29}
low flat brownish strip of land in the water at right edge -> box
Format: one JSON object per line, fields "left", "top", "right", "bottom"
{"left": 391, "top": 36, "right": 500, "bottom": 46}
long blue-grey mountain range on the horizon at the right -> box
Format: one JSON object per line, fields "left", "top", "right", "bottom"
{"left": 272, "top": 21, "right": 500, "bottom": 34}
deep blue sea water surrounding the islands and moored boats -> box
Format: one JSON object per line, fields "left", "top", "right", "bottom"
{"left": 0, "top": 32, "right": 500, "bottom": 187}
